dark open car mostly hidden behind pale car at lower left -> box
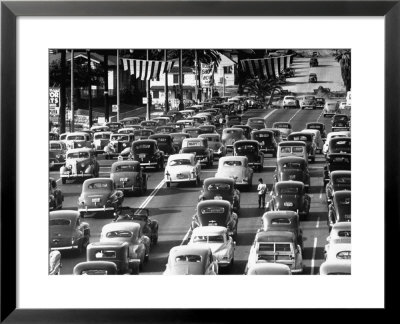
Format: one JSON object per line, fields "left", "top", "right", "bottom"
{"left": 114, "top": 207, "right": 158, "bottom": 245}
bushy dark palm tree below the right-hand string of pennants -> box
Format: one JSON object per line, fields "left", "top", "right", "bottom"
{"left": 244, "top": 78, "right": 282, "bottom": 107}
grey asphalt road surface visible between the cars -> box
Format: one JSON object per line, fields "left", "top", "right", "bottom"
{"left": 50, "top": 55, "right": 346, "bottom": 275}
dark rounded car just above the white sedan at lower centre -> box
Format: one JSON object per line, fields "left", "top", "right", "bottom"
{"left": 191, "top": 199, "right": 239, "bottom": 239}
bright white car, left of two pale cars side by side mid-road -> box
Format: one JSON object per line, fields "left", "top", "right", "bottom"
{"left": 164, "top": 153, "right": 201, "bottom": 188}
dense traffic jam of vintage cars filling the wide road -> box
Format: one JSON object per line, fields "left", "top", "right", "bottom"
{"left": 49, "top": 52, "right": 351, "bottom": 275}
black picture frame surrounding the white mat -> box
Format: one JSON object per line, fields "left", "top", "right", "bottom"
{"left": 0, "top": 0, "right": 400, "bottom": 323}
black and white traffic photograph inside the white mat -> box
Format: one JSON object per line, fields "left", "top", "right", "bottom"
{"left": 48, "top": 48, "right": 352, "bottom": 276}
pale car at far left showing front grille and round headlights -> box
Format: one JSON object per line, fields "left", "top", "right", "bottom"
{"left": 60, "top": 148, "right": 100, "bottom": 184}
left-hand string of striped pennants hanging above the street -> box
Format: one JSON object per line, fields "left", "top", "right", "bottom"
{"left": 122, "top": 58, "right": 175, "bottom": 80}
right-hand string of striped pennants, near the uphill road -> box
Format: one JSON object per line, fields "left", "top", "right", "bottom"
{"left": 240, "top": 55, "right": 293, "bottom": 79}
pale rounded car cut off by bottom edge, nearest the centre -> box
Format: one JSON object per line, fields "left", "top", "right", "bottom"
{"left": 163, "top": 245, "right": 218, "bottom": 276}
